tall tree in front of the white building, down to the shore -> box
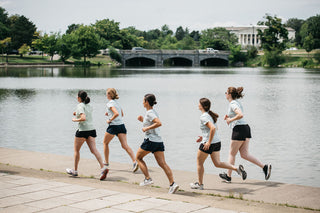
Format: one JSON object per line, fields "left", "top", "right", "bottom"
{"left": 258, "top": 15, "right": 288, "bottom": 67}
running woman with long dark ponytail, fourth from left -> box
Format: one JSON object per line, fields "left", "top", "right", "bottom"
{"left": 190, "top": 98, "right": 247, "bottom": 190}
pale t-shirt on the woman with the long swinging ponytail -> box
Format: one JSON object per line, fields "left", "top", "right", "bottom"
{"left": 200, "top": 112, "right": 220, "bottom": 144}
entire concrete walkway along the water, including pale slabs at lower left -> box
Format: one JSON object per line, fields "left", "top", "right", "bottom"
{"left": 0, "top": 148, "right": 320, "bottom": 212}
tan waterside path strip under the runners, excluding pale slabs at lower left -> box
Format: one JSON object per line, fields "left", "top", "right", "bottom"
{"left": 0, "top": 148, "right": 320, "bottom": 212}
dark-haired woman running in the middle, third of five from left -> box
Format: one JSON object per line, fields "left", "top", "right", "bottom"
{"left": 136, "top": 94, "right": 179, "bottom": 194}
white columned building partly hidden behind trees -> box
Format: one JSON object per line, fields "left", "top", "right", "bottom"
{"left": 225, "top": 26, "right": 295, "bottom": 47}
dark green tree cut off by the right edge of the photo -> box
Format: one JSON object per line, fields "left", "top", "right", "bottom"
{"left": 300, "top": 15, "right": 320, "bottom": 51}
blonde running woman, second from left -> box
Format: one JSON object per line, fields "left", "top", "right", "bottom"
{"left": 103, "top": 88, "right": 139, "bottom": 179}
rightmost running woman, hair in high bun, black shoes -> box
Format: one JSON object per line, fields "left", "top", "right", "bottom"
{"left": 219, "top": 87, "right": 272, "bottom": 182}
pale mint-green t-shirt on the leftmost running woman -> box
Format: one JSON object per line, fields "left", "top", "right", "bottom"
{"left": 76, "top": 103, "right": 94, "bottom": 131}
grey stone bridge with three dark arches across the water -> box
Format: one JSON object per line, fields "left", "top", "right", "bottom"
{"left": 120, "top": 49, "right": 230, "bottom": 67}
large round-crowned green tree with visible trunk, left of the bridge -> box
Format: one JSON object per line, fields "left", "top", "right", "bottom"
{"left": 71, "top": 25, "right": 101, "bottom": 65}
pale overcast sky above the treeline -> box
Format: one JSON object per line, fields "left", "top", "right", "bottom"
{"left": 0, "top": 0, "right": 320, "bottom": 33}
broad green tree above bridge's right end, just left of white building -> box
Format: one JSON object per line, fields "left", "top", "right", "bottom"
{"left": 200, "top": 27, "right": 238, "bottom": 50}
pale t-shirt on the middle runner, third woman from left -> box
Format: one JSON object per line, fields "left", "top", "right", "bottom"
{"left": 143, "top": 109, "right": 162, "bottom": 142}
